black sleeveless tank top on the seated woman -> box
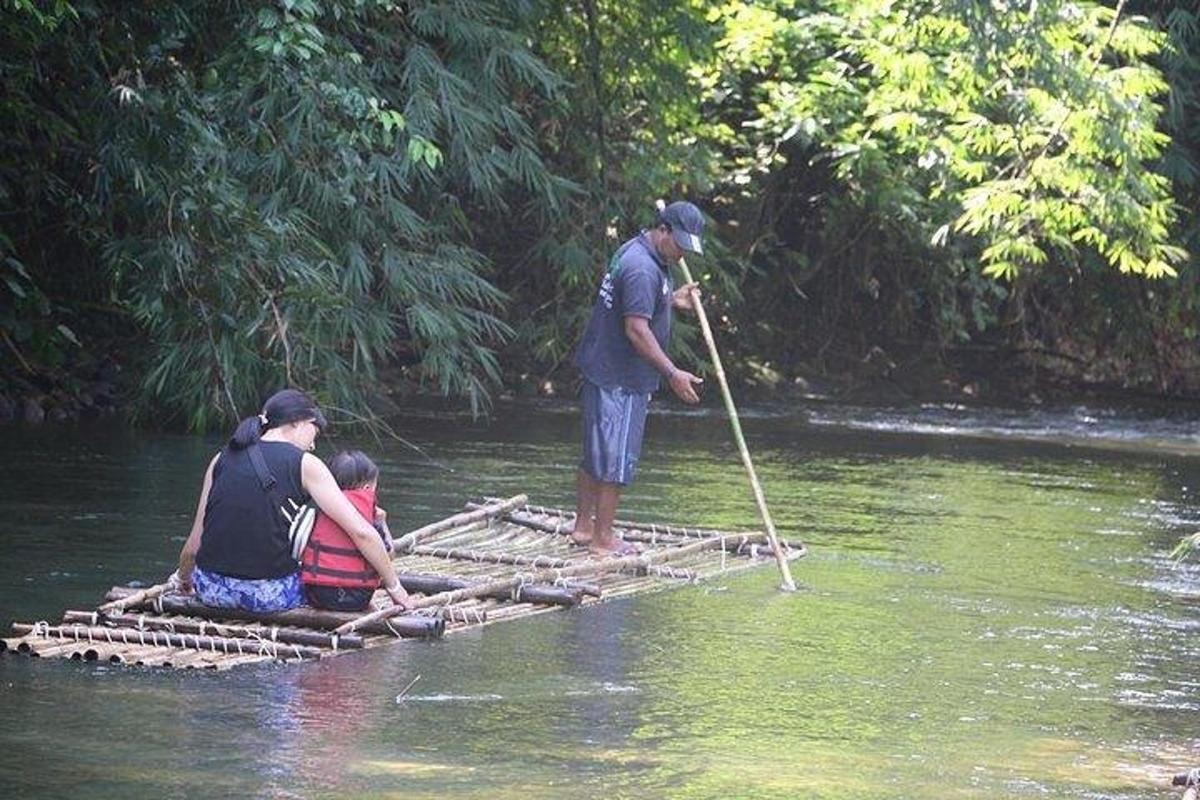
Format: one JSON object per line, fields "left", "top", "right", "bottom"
{"left": 196, "top": 441, "right": 308, "bottom": 581}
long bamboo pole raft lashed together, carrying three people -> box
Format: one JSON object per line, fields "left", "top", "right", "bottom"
{"left": 0, "top": 495, "right": 806, "bottom": 669}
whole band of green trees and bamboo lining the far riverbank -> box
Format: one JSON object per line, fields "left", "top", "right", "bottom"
{"left": 0, "top": 0, "right": 1200, "bottom": 429}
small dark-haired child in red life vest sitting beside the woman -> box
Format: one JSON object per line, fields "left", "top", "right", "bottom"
{"left": 300, "top": 450, "right": 392, "bottom": 610}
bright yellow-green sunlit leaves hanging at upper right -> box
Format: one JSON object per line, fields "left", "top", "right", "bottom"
{"left": 714, "top": 0, "right": 1184, "bottom": 278}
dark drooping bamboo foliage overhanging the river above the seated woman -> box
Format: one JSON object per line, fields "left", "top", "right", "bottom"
{"left": 78, "top": 1, "right": 566, "bottom": 427}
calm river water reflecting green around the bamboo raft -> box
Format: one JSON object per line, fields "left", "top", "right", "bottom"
{"left": 0, "top": 403, "right": 1200, "bottom": 800}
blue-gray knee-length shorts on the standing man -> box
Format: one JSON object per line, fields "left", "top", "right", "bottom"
{"left": 580, "top": 380, "right": 650, "bottom": 486}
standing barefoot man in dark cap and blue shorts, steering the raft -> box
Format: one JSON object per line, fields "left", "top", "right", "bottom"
{"left": 571, "top": 201, "right": 704, "bottom": 555}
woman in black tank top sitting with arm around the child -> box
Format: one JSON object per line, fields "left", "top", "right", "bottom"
{"left": 173, "top": 389, "right": 408, "bottom": 612}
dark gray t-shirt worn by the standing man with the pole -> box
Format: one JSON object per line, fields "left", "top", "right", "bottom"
{"left": 575, "top": 231, "right": 674, "bottom": 392}
